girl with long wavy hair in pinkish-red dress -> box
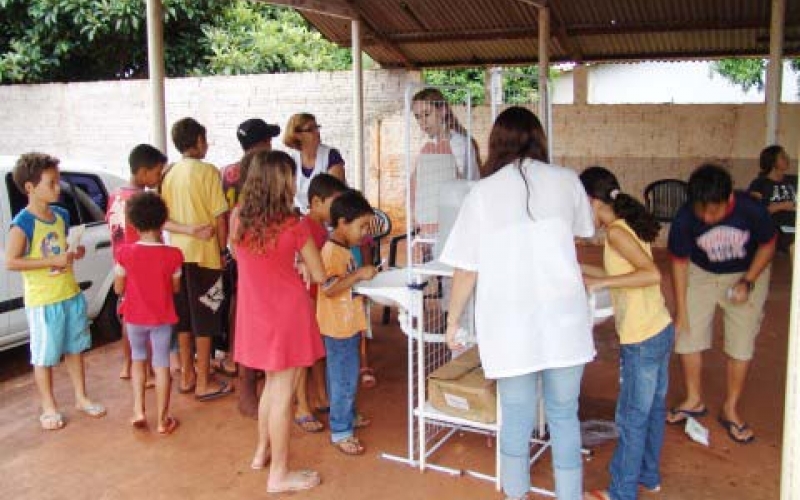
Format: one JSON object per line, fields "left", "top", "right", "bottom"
{"left": 231, "top": 151, "right": 325, "bottom": 493}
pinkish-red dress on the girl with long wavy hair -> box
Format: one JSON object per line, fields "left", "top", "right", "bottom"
{"left": 234, "top": 220, "right": 325, "bottom": 371}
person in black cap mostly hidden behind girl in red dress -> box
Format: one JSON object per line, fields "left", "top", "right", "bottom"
{"left": 217, "top": 118, "right": 281, "bottom": 418}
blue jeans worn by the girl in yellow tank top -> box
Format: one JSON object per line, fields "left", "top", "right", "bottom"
{"left": 608, "top": 323, "right": 675, "bottom": 500}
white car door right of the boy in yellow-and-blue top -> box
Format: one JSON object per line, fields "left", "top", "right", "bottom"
{"left": 59, "top": 171, "right": 113, "bottom": 318}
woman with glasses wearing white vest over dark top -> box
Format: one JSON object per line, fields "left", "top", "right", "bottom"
{"left": 283, "top": 113, "right": 345, "bottom": 214}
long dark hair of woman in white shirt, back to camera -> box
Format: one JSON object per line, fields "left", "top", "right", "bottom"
{"left": 481, "top": 106, "right": 548, "bottom": 219}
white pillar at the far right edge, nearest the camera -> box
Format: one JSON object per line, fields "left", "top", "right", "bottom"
{"left": 781, "top": 138, "right": 800, "bottom": 500}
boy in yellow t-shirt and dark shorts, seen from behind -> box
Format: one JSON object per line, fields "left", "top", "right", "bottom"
{"left": 161, "top": 118, "right": 233, "bottom": 401}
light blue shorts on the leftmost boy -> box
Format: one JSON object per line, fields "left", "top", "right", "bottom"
{"left": 25, "top": 293, "right": 92, "bottom": 366}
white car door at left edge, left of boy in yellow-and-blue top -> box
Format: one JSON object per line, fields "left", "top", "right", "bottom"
{"left": 0, "top": 173, "right": 28, "bottom": 350}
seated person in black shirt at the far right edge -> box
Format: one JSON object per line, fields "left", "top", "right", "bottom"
{"left": 747, "top": 144, "right": 797, "bottom": 252}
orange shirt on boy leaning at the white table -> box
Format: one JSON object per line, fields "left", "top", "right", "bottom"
{"left": 317, "top": 241, "right": 367, "bottom": 339}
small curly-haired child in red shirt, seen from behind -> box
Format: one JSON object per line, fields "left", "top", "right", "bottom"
{"left": 114, "top": 192, "right": 183, "bottom": 435}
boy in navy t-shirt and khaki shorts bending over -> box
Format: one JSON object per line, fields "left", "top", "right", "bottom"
{"left": 667, "top": 164, "right": 776, "bottom": 444}
